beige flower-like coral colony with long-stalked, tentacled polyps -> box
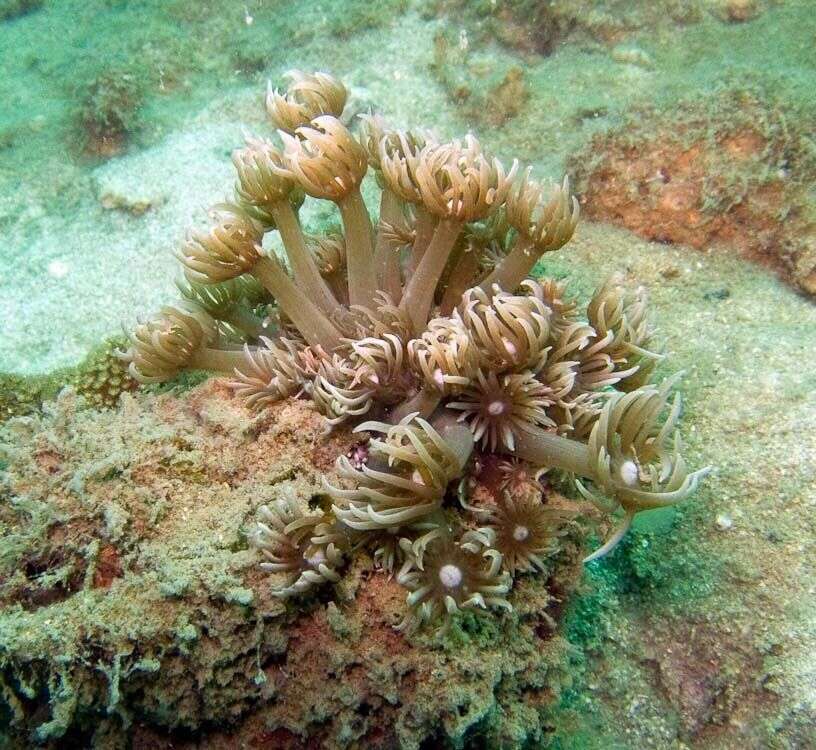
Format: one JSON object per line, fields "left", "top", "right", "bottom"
{"left": 121, "top": 71, "right": 706, "bottom": 630}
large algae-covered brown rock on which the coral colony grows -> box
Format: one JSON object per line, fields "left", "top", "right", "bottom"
{"left": 0, "top": 381, "right": 579, "bottom": 748}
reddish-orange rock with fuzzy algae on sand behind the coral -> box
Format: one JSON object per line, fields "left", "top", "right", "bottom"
{"left": 570, "top": 87, "right": 816, "bottom": 294}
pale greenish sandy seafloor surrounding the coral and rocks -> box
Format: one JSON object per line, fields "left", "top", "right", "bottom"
{"left": 0, "top": 0, "right": 816, "bottom": 748}
